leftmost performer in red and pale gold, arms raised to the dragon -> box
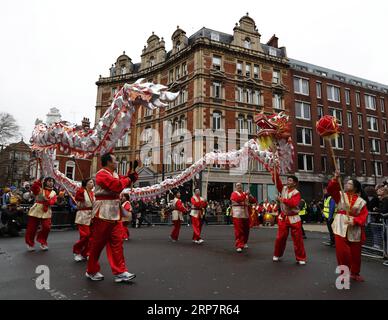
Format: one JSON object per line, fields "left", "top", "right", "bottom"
{"left": 25, "top": 177, "right": 57, "bottom": 251}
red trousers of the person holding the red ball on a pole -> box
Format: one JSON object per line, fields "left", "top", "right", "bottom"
{"left": 335, "top": 235, "right": 362, "bottom": 275}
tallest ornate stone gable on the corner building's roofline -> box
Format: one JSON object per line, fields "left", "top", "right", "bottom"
{"left": 232, "top": 13, "right": 263, "bottom": 52}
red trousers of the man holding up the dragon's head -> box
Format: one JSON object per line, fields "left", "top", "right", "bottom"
{"left": 274, "top": 217, "right": 306, "bottom": 261}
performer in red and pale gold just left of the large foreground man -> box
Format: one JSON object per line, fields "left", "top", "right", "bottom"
{"left": 73, "top": 179, "right": 95, "bottom": 262}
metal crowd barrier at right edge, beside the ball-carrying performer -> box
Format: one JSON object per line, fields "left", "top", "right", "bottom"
{"left": 362, "top": 212, "right": 388, "bottom": 259}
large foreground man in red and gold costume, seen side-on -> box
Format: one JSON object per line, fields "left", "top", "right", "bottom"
{"left": 85, "top": 153, "right": 138, "bottom": 282}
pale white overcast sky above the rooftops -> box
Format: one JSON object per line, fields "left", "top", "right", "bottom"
{"left": 0, "top": 0, "right": 388, "bottom": 140}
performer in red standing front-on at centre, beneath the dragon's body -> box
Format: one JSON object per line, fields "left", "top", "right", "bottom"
{"left": 230, "top": 183, "right": 249, "bottom": 253}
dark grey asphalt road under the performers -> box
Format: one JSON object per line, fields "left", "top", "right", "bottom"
{"left": 0, "top": 226, "right": 388, "bottom": 301}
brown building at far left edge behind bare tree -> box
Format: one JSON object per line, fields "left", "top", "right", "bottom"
{"left": 0, "top": 140, "right": 31, "bottom": 187}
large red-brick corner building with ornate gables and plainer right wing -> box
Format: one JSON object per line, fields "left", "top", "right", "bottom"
{"left": 92, "top": 14, "right": 388, "bottom": 200}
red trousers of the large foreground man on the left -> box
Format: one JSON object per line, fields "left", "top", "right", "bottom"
{"left": 87, "top": 218, "right": 128, "bottom": 275}
